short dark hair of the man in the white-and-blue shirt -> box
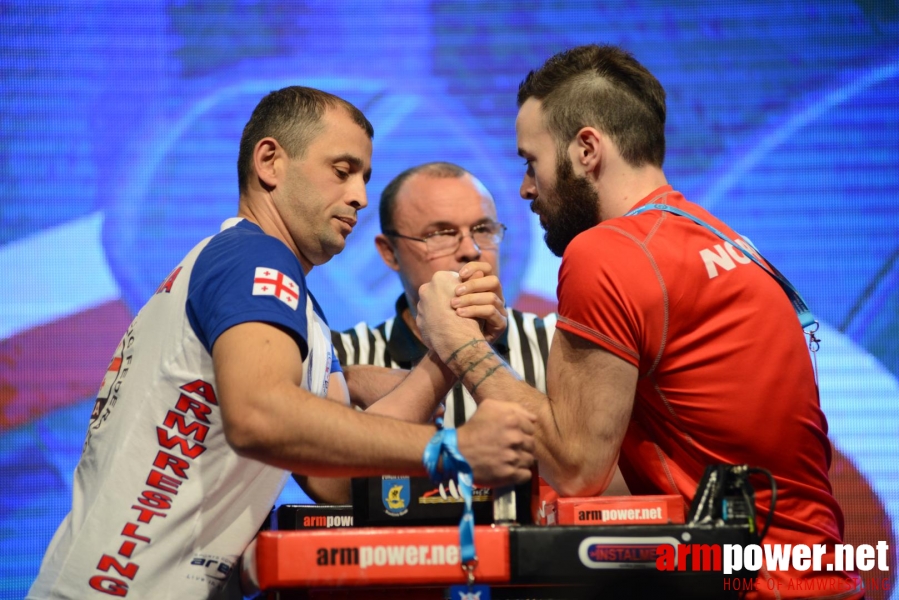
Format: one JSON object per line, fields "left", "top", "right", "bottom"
{"left": 237, "top": 85, "right": 375, "bottom": 193}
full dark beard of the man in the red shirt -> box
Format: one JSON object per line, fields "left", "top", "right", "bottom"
{"left": 531, "top": 153, "right": 599, "bottom": 257}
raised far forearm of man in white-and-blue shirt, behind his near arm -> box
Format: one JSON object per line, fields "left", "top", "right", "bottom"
{"left": 366, "top": 351, "right": 456, "bottom": 423}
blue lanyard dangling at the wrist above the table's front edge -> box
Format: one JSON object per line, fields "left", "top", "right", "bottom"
{"left": 422, "top": 429, "right": 478, "bottom": 564}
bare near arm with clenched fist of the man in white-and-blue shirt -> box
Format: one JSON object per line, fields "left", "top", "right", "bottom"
{"left": 212, "top": 321, "right": 533, "bottom": 485}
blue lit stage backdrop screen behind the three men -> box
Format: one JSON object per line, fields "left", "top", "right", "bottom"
{"left": 0, "top": 0, "right": 899, "bottom": 599}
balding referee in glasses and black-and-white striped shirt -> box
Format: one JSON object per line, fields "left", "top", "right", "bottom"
{"left": 331, "top": 162, "right": 556, "bottom": 427}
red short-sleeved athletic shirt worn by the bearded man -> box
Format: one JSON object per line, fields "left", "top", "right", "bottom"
{"left": 557, "top": 186, "right": 862, "bottom": 598}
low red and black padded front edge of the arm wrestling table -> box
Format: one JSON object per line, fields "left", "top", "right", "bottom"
{"left": 245, "top": 525, "right": 756, "bottom": 600}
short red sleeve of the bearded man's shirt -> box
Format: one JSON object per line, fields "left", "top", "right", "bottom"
{"left": 557, "top": 225, "right": 668, "bottom": 375}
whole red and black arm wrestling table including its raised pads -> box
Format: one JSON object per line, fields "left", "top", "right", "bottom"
{"left": 243, "top": 465, "right": 776, "bottom": 600}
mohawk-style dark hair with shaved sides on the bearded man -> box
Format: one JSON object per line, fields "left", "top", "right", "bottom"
{"left": 518, "top": 44, "right": 665, "bottom": 167}
